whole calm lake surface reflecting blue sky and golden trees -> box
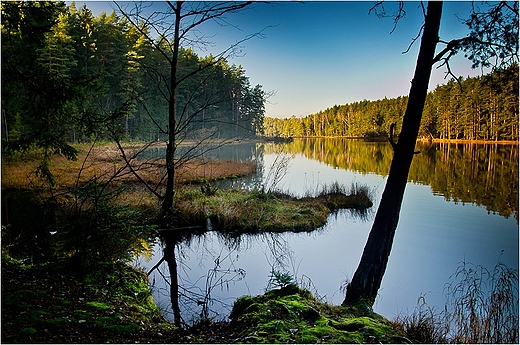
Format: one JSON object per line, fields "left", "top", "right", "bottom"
{"left": 133, "top": 139, "right": 519, "bottom": 323}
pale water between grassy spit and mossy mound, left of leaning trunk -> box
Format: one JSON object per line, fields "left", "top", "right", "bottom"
{"left": 136, "top": 210, "right": 374, "bottom": 325}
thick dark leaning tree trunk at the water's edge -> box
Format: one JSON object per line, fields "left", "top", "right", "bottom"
{"left": 343, "top": 1, "right": 442, "bottom": 306}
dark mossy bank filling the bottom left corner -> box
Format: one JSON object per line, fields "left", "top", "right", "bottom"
{"left": 2, "top": 256, "right": 182, "bottom": 343}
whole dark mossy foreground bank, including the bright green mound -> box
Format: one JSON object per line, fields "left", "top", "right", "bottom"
{"left": 2, "top": 256, "right": 408, "bottom": 343}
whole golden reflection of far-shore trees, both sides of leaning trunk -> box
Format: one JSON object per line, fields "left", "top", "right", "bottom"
{"left": 266, "top": 138, "right": 518, "bottom": 221}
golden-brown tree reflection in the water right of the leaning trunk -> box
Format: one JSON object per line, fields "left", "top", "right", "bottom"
{"left": 420, "top": 144, "right": 518, "bottom": 221}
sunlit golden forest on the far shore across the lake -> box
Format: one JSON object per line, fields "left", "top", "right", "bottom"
{"left": 264, "top": 64, "right": 519, "bottom": 141}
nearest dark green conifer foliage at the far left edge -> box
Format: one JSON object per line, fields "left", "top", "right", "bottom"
{"left": 2, "top": 2, "right": 91, "bottom": 159}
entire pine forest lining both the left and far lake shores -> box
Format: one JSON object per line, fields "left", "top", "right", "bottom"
{"left": 2, "top": 2, "right": 519, "bottom": 150}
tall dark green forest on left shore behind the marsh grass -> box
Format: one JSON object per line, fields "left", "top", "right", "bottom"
{"left": 2, "top": 2, "right": 265, "bottom": 153}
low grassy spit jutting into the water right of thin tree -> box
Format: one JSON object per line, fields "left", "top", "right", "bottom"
{"left": 176, "top": 184, "right": 372, "bottom": 233}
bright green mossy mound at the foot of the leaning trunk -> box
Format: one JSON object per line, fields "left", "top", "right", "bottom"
{"left": 230, "top": 285, "right": 407, "bottom": 344}
